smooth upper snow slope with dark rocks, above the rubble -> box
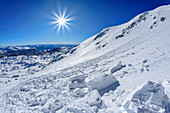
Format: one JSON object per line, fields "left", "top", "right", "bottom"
{"left": 41, "top": 6, "right": 170, "bottom": 73}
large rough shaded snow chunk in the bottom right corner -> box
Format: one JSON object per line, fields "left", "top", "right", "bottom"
{"left": 124, "top": 81, "right": 169, "bottom": 113}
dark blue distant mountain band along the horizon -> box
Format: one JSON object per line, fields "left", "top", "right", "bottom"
{"left": 0, "top": 44, "right": 77, "bottom": 58}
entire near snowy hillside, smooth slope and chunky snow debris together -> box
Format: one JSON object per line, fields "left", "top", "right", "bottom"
{"left": 0, "top": 5, "right": 170, "bottom": 113}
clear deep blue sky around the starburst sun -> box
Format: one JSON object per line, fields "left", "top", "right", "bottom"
{"left": 0, "top": 0, "right": 170, "bottom": 46}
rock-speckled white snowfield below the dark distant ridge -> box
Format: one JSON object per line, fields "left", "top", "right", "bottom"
{"left": 0, "top": 47, "right": 69, "bottom": 84}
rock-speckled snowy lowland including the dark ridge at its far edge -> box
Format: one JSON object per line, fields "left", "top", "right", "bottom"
{"left": 0, "top": 47, "right": 73, "bottom": 84}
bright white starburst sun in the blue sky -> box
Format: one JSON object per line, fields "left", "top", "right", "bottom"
{"left": 50, "top": 10, "right": 74, "bottom": 32}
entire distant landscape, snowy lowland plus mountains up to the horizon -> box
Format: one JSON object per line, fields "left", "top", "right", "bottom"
{"left": 0, "top": 44, "right": 75, "bottom": 84}
